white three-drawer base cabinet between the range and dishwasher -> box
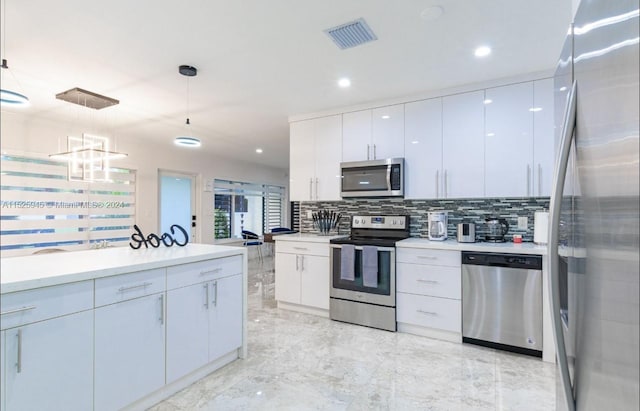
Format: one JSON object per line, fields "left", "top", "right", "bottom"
{"left": 396, "top": 248, "right": 462, "bottom": 341}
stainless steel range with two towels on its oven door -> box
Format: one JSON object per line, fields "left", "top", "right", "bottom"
{"left": 329, "top": 215, "right": 409, "bottom": 331}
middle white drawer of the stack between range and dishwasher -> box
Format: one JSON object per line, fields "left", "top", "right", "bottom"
{"left": 396, "top": 263, "right": 462, "bottom": 300}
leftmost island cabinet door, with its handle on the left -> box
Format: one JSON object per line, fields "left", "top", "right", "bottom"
{"left": 2, "top": 311, "right": 93, "bottom": 411}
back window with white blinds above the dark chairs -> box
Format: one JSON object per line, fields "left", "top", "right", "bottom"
{"left": 214, "top": 179, "right": 285, "bottom": 239}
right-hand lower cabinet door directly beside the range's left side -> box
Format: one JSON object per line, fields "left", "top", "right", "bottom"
{"left": 299, "top": 255, "right": 330, "bottom": 310}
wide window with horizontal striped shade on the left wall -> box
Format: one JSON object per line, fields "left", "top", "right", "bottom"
{"left": 0, "top": 155, "right": 136, "bottom": 257}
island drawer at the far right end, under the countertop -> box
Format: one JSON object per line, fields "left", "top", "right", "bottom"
{"left": 167, "top": 255, "right": 242, "bottom": 290}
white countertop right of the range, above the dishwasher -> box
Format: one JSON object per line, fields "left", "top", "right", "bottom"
{"left": 396, "top": 237, "right": 547, "bottom": 255}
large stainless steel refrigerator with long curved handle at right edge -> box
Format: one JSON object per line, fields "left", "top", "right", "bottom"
{"left": 549, "top": 0, "right": 640, "bottom": 411}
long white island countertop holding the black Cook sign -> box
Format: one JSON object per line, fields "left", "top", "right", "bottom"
{"left": 0, "top": 244, "right": 247, "bottom": 294}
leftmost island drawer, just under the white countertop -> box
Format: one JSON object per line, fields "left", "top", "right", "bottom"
{"left": 0, "top": 281, "right": 93, "bottom": 330}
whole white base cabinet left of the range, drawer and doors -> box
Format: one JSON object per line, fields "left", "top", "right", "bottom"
{"left": 275, "top": 241, "right": 330, "bottom": 310}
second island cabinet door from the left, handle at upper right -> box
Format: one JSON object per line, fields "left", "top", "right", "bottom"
{"left": 95, "top": 293, "right": 166, "bottom": 411}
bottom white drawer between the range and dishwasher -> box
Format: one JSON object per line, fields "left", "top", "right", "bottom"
{"left": 396, "top": 293, "right": 462, "bottom": 333}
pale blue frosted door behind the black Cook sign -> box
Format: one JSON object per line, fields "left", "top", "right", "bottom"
{"left": 158, "top": 170, "right": 197, "bottom": 243}
